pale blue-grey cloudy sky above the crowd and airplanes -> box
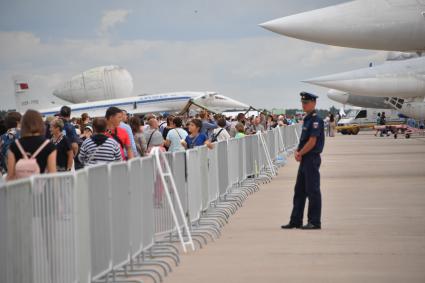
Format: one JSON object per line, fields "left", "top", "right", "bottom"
{"left": 0, "top": 0, "right": 385, "bottom": 112}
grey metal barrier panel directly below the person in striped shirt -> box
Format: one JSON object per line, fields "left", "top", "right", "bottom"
{"left": 87, "top": 164, "right": 112, "bottom": 280}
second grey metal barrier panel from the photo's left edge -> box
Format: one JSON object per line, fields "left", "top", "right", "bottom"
{"left": 32, "top": 173, "right": 78, "bottom": 283}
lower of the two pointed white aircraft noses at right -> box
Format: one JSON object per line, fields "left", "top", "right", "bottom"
{"left": 305, "top": 57, "right": 425, "bottom": 120}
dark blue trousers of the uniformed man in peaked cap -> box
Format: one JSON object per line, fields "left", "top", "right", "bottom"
{"left": 291, "top": 153, "right": 322, "bottom": 226}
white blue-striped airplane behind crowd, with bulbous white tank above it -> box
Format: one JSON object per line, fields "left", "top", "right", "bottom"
{"left": 14, "top": 66, "right": 250, "bottom": 117}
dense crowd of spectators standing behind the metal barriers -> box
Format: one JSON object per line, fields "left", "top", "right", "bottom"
{"left": 0, "top": 106, "right": 302, "bottom": 180}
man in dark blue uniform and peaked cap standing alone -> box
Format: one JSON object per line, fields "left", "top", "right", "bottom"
{"left": 281, "top": 92, "right": 325, "bottom": 230}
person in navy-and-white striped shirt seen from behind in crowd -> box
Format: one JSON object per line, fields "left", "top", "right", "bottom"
{"left": 78, "top": 118, "right": 122, "bottom": 166}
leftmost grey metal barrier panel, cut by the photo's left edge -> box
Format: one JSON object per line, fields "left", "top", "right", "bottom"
{"left": 0, "top": 179, "right": 34, "bottom": 283}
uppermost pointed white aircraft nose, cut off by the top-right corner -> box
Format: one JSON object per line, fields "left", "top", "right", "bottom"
{"left": 260, "top": 0, "right": 425, "bottom": 51}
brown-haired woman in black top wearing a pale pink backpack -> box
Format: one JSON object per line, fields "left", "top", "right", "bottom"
{"left": 7, "top": 110, "right": 56, "bottom": 180}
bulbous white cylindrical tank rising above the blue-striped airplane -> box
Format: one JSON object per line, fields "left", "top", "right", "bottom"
{"left": 53, "top": 66, "right": 133, "bottom": 103}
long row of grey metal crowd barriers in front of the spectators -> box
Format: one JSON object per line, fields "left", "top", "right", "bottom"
{"left": 0, "top": 125, "right": 301, "bottom": 283}
